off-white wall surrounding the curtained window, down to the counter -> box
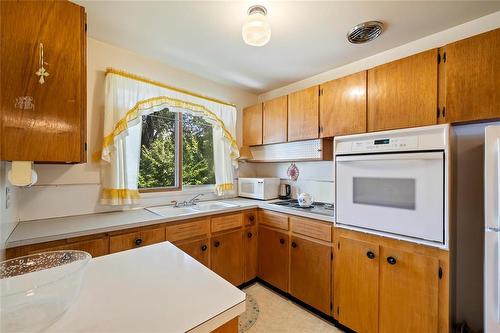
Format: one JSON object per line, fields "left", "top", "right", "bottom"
{"left": 15, "top": 38, "right": 257, "bottom": 221}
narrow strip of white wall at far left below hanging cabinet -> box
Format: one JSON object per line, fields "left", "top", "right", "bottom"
{"left": 0, "top": 161, "right": 19, "bottom": 261}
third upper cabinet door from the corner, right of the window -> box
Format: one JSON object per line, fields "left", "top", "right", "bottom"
{"left": 288, "top": 86, "right": 319, "bottom": 141}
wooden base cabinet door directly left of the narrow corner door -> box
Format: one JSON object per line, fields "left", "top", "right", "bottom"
{"left": 210, "top": 230, "right": 244, "bottom": 286}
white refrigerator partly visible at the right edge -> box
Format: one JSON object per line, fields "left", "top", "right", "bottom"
{"left": 484, "top": 126, "right": 500, "bottom": 333}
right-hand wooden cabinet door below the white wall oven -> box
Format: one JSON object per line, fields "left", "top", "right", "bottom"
{"left": 379, "top": 247, "right": 439, "bottom": 333}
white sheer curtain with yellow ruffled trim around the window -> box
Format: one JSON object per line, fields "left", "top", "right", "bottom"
{"left": 100, "top": 70, "right": 239, "bottom": 205}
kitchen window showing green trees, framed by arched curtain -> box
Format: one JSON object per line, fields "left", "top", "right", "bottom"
{"left": 138, "top": 109, "right": 215, "bottom": 192}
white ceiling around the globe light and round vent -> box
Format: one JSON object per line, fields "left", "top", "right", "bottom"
{"left": 77, "top": 0, "right": 500, "bottom": 93}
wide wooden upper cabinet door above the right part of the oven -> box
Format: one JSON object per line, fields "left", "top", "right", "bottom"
{"left": 367, "top": 49, "right": 438, "bottom": 131}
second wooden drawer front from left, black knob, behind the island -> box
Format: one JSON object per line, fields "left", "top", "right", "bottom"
{"left": 109, "top": 227, "right": 165, "bottom": 253}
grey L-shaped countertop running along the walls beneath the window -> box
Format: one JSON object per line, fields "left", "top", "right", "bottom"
{"left": 6, "top": 198, "right": 334, "bottom": 248}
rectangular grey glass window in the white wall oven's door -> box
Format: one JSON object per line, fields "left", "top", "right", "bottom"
{"left": 353, "top": 177, "right": 415, "bottom": 210}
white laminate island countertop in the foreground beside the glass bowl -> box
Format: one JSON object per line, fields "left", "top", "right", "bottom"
{"left": 46, "top": 242, "right": 246, "bottom": 333}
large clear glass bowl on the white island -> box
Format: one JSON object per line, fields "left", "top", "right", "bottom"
{"left": 0, "top": 251, "right": 92, "bottom": 332}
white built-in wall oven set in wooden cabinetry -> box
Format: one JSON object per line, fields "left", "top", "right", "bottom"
{"left": 335, "top": 125, "right": 449, "bottom": 247}
